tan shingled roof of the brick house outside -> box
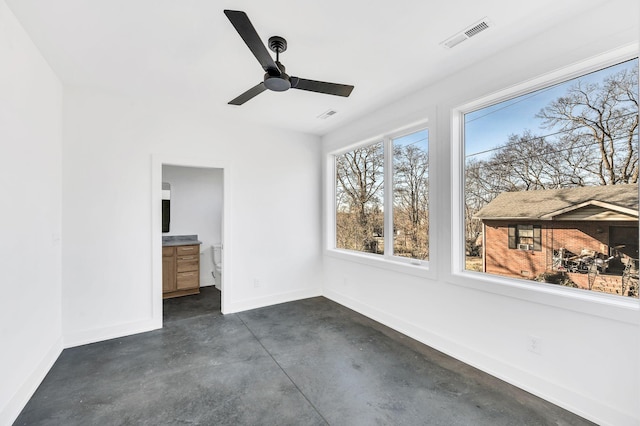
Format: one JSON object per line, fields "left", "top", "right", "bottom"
{"left": 474, "top": 184, "right": 638, "bottom": 220}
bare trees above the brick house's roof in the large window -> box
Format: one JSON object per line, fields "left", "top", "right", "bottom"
{"left": 465, "top": 67, "right": 638, "bottom": 262}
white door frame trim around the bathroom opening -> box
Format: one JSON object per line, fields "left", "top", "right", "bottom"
{"left": 150, "top": 154, "right": 232, "bottom": 328}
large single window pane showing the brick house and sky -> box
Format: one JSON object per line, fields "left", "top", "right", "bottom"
{"left": 464, "top": 59, "right": 639, "bottom": 297}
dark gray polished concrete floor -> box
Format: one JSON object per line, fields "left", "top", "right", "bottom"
{"left": 15, "top": 287, "right": 592, "bottom": 426}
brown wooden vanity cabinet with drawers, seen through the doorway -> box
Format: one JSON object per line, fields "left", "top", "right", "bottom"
{"left": 162, "top": 245, "right": 200, "bottom": 299}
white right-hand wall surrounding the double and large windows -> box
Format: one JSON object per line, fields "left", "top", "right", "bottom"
{"left": 323, "top": 0, "right": 640, "bottom": 426}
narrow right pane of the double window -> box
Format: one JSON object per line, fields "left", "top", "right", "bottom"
{"left": 392, "top": 130, "right": 429, "bottom": 260}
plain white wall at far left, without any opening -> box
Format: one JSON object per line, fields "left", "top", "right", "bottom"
{"left": 0, "top": 0, "right": 62, "bottom": 425}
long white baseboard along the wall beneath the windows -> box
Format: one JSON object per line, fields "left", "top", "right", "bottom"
{"left": 323, "top": 289, "right": 640, "bottom": 426}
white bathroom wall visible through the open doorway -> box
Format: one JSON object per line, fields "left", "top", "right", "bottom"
{"left": 162, "top": 165, "right": 223, "bottom": 287}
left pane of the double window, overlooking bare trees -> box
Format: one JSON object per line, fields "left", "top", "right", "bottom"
{"left": 336, "top": 142, "right": 384, "bottom": 254}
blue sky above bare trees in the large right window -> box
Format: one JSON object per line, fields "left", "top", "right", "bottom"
{"left": 465, "top": 60, "right": 638, "bottom": 159}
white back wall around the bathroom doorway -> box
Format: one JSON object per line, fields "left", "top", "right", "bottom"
{"left": 63, "top": 88, "right": 322, "bottom": 345}
